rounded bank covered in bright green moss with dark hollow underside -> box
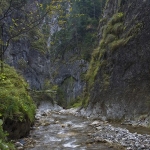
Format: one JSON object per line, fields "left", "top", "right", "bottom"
{"left": 0, "top": 65, "right": 36, "bottom": 138}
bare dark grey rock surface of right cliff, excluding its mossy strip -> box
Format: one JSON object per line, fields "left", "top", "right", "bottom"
{"left": 87, "top": 0, "right": 150, "bottom": 126}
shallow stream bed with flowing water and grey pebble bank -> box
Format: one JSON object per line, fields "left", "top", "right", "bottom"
{"left": 16, "top": 104, "right": 150, "bottom": 150}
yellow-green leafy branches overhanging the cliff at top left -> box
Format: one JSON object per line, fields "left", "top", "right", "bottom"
{"left": 0, "top": 0, "right": 50, "bottom": 72}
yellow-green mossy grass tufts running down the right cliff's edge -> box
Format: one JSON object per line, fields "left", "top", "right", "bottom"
{"left": 84, "top": 7, "right": 143, "bottom": 105}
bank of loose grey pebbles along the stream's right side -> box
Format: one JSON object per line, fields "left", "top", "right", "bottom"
{"left": 60, "top": 110, "right": 150, "bottom": 150}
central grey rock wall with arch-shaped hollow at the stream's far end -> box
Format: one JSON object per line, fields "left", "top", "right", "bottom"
{"left": 51, "top": 51, "right": 88, "bottom": 105}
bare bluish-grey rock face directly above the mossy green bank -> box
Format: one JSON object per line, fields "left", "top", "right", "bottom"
{"left": 5, "top": 38, "right": 50, "bottom": 89}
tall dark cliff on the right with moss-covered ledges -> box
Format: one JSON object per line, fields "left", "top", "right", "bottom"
{"left": 87, "top": 0, "right": 150, "bottom": 122}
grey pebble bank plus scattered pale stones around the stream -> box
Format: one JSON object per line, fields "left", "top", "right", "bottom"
{"left": 22, "top": 106, "right": 150, "bottom": 150}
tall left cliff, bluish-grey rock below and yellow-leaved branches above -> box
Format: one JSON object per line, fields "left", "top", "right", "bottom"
{"left": 0, "top": 0, "right": 50, "bottom": 89}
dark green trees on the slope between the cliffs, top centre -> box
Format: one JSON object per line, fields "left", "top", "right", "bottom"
{"left": 51, "top": 0, "right": 105, "bottom": 61}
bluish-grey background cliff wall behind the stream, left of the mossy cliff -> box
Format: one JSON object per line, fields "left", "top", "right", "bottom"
{"left": 5, "top": 2, "right": 87, "bottom": 105}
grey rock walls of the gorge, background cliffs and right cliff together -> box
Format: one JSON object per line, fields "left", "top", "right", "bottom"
{"left": 5, "top": 0, "right": 150, "bottom": 126}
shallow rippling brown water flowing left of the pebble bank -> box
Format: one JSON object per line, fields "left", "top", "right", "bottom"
{"left": 25, "top": 112, "right": 115, "bottom": 150}
